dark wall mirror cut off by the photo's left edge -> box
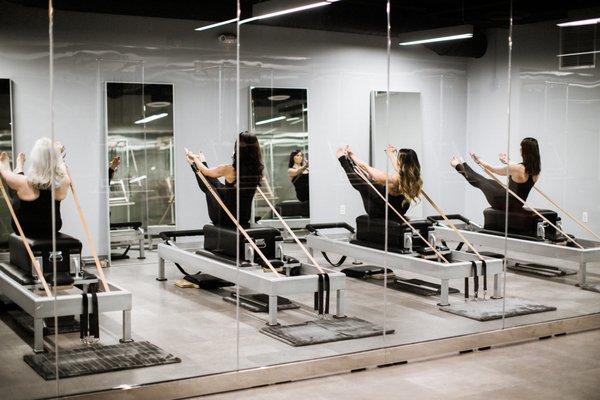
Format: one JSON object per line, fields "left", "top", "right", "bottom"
{"left": 0, "top": 79, "right": 13, "bottom": 248}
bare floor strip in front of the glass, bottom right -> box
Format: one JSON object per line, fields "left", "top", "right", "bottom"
{"left": 202, "top": 331, "right": 600, "bottom": 400}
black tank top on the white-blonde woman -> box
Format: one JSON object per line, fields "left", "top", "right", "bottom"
{"left": 11, "top": 189, "right": 62, "bottom": 238}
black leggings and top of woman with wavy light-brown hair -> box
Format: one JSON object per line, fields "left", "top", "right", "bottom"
{"left": 338, "top": 156, "right": 410, "bottom": 221}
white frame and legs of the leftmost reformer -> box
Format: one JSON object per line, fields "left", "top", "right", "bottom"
{"left": 0, "top": 271, "right": 132, "bottom": 353}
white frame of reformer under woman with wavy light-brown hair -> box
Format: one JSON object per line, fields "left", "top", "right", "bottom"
{"left": 306, "top": 224, "right": 502, "bottom": 306}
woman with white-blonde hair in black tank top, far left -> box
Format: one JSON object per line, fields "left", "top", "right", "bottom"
{"left": 0, "top": 138, "right": 71, "bottom": 238}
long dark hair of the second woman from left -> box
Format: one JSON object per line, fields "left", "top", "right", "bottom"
{"left": 232, "top": 131, "right": 265, "bottom": 189}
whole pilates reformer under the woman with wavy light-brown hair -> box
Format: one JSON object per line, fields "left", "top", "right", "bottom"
{"left": 306, "top": 153, "right": 502, "bottom": 306}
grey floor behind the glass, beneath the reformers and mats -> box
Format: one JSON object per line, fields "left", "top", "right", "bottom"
{"left": 0, "top": 245, "right": 600, "bottom": 399}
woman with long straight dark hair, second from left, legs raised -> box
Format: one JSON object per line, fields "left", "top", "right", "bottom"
{"left": 186, "top": 132, "right": 264, "bottom": 227}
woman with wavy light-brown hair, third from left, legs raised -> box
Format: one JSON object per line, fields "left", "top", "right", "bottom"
{"left": 336, "top": 146, "right": 423, "bottom": 221}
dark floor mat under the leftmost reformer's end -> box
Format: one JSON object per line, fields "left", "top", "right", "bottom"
{"left": 23, "top": 342, "right": 181, "bottom": 380}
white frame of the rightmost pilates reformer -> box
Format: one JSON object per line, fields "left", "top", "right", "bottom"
{"left": 434, "top": 214, "right": 600, "bottom": 286}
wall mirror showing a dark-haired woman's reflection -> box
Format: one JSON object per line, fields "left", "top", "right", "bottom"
{"left": 250, "top": 87, "right": 310, "bottom": 228}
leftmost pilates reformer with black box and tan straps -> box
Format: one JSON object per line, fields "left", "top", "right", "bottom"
{"left": 0, "top": 169, "right": 132, "bottom": 353}
